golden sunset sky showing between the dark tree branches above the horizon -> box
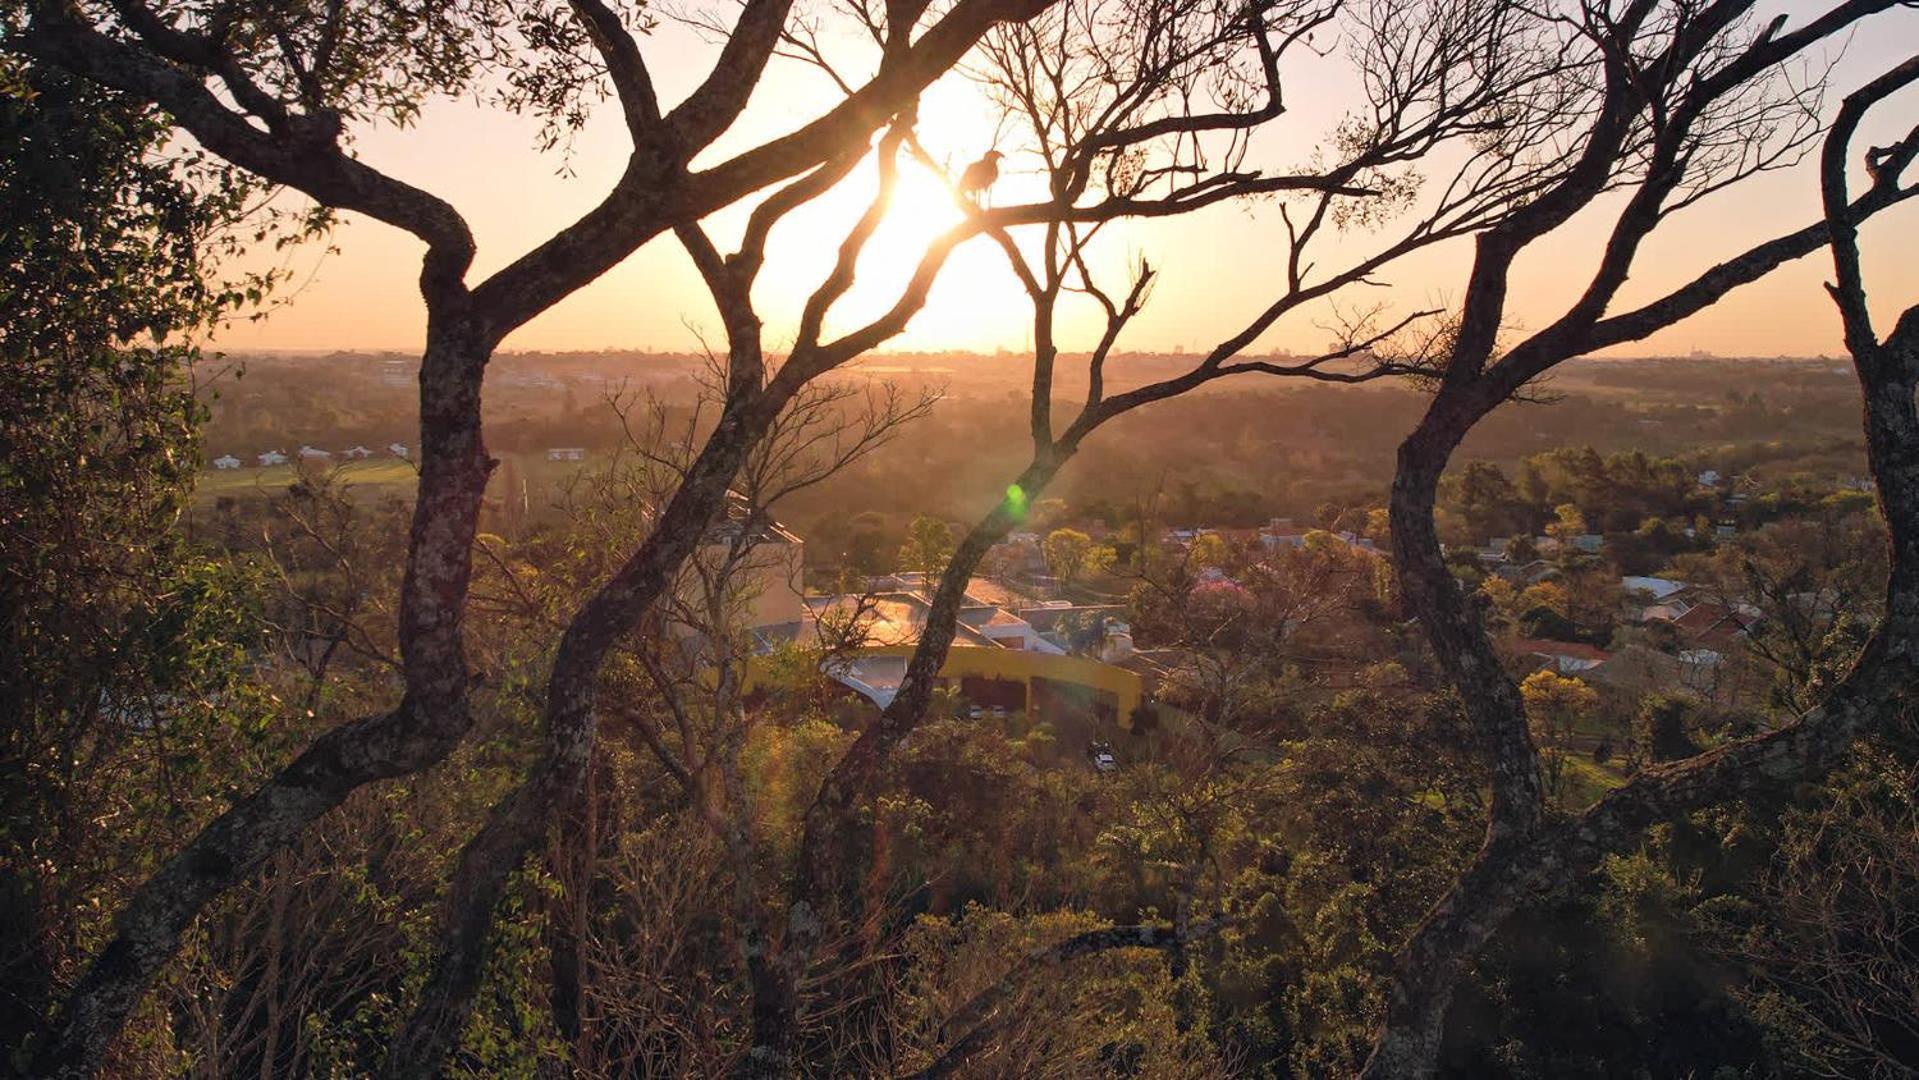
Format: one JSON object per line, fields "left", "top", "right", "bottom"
{"left": 215, "top": 4, "right": 1919, "bottom": 355}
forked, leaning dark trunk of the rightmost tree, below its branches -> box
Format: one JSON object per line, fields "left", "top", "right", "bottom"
{"left": 1362, "top": 309, "right": 1919, "bottom": 1078}
